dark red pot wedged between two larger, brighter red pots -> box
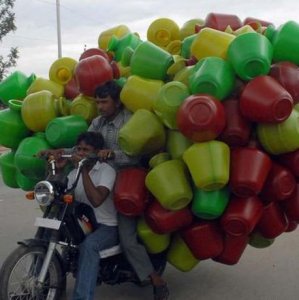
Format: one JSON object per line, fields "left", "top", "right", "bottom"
{"left": 219, "top": 99, "right": 252, "bottom": 147}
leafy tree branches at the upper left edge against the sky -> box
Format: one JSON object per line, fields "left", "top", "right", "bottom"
{"left": 0, "top": 0, "right": 19, "bottom": 81}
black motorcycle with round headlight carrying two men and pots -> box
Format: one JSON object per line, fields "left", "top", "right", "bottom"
{"left": 0, "top": 155, "right": 166, "bottom": 300}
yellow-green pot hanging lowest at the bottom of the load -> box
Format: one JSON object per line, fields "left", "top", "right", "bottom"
{"left": 167, "top": 234, "right": 199, "bottom": 272}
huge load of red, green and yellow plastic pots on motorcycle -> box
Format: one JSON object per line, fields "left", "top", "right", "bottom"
{"left": 0, "top": 13, "right": 299, "bottom": 272}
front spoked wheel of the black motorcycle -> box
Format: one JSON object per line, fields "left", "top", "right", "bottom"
{"left": 0, "top": 245, "right": 66, "bottom": 300}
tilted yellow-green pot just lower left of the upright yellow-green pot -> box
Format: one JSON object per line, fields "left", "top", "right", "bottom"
{"left": 145, "top": 160, "right": 193, "bottom": 210}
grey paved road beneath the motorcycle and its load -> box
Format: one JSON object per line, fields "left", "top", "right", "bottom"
{"left": 0, "top": 178, "right": 299, "bottom": 300}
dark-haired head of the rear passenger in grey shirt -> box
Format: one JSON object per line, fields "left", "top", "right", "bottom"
{"left": 95, "top": 80, "right": 122, "bottom": 119}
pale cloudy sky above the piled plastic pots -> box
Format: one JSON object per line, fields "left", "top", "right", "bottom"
{"left": 0, "top": 0, "right": 299, "bottom": 78}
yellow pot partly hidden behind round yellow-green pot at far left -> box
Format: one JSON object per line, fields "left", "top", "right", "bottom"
{"left": 27, "top": 77, "right": 64, "bottom": 98}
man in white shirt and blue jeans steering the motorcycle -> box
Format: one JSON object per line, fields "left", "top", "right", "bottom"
{"left": 68, "top": 132, "right": 118, "bottom": 300}
